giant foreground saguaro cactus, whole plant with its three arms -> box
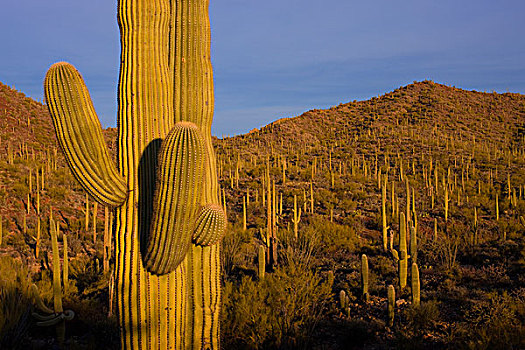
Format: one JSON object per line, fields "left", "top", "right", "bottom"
{"left": 45, "top": 0, "right": 226, "bottom": 349}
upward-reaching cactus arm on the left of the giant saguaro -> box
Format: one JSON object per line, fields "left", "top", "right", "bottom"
{"left": 44, "top": 62, "right": 128, "bottom": 207}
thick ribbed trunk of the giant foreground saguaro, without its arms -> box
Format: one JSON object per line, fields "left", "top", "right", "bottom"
{"left": 117, "top": 0, "right": 220, "bottom": 349}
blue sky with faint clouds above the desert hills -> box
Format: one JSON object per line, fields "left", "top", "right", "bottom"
{"left": 0, "top": 0, "right": 525, "bottom": 136}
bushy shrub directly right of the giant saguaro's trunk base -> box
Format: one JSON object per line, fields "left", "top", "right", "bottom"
{"left": 222, "top": 265, "right": 331, "bottom": 349}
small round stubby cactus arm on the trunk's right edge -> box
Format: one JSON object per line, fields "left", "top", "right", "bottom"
{"left": 193, "top": 204, "right": 227, "bottom": 246}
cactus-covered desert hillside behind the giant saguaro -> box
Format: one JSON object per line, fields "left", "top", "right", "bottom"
{"left": 0, "top": 77, "right": 525, "bottom": 349}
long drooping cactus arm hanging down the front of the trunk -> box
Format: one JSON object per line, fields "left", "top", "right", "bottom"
{"left": 144, "top": 122, "right": 206, "bottom": 275}
